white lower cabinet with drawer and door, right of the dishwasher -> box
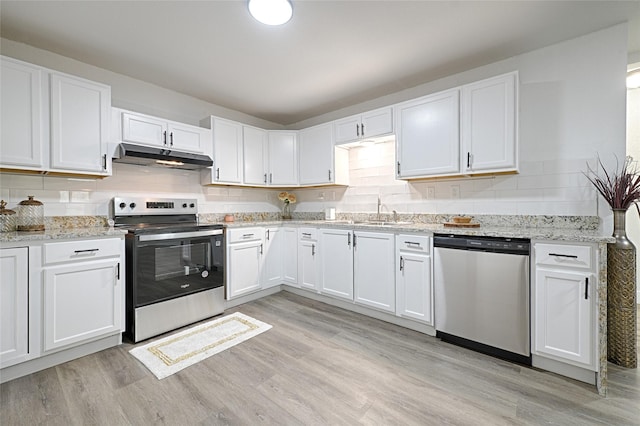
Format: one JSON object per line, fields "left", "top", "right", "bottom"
{"left": 532, "top": 243, "right": 597, "bottom": 371}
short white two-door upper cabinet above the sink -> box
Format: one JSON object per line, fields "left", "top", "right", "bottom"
{"left": 334, "top": 107, "right": 393, "bottom": 144}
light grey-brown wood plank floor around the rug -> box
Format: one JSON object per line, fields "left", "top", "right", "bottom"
{"left": 0, "top": 291, "right": 640, "bottom": 426}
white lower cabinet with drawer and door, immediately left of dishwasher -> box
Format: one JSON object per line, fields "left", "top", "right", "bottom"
{"left": 396, "top": 234, "right": 433, "bottom": 325}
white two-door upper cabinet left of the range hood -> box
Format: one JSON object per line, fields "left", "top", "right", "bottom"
{"left": 0, "top": 57, "right": 111, "bottom": 176}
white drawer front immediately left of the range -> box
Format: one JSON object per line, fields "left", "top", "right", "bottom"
{"left": 42, "top": 238, "right": 124, "bottom": 265}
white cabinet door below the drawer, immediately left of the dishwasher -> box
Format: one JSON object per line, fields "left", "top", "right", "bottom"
{"left": 396, "top": 251, "right": 433, "bottom": 325}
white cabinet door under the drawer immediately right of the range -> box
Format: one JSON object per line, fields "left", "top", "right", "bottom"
{"left": 227, "top": 240, "right": 264, "bottom": 299}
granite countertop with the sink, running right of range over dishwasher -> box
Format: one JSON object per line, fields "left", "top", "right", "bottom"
{"left": 221, "top": 220, "right": 615, "bottom": 243}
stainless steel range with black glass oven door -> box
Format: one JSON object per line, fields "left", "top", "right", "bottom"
{"left": 112, "top": 197, "right": 225, "bottom": 342}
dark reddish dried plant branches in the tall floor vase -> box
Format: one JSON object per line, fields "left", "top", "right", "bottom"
{"left": 585, "top": 156, "right": 640, "bottom": 215}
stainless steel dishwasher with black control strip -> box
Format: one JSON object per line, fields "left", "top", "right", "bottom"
{"left": 433, "top": 234, "right": 531, "bottom": 365}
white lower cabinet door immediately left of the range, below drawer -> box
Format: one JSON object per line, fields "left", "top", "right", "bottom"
{"left": 44, "top": 259, "right": 124, "bottom": 351}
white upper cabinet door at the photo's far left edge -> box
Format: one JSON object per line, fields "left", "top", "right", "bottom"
{"left": 0, "top": 58, "right": 48, "bottom": 170}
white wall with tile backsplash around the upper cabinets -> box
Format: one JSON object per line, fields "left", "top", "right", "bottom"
{"left": 0, "top": 25, "right": 627, "bottom": 221}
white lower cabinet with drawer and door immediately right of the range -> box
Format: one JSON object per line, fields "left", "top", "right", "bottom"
{"left": 226, "top": 228, "right": 264, "bottom": 299}
